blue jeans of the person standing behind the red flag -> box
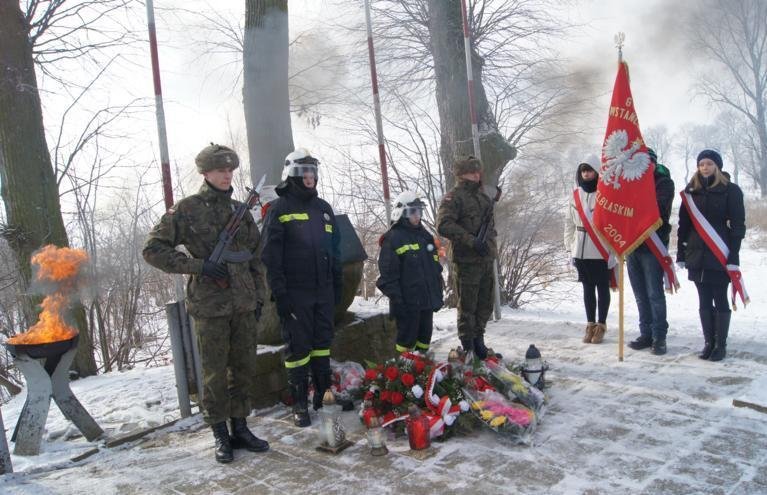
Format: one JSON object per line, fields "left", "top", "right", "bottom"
{"left": 626, "top": 247, "right": 668, "bottom": 340}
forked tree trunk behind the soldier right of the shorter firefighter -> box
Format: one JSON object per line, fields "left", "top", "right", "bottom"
{"left": 429, "top": 0, "right": 517, "bottom": 188}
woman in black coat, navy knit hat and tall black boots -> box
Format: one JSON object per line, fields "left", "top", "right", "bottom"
{"left": 677, "top": 150, "right": 746, "bottom": 361}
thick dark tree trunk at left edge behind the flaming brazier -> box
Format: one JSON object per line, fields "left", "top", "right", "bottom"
{"left": 0, "top": 1, "right": 96, "bottom": 376}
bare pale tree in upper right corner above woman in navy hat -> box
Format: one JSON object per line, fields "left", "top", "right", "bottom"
{"left": 689, "top": 0, "right": 767, "bottom": 197}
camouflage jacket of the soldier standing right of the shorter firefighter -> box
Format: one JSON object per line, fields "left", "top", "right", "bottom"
{"left": 437, "top": 180, "right": 497, "bottom": 263}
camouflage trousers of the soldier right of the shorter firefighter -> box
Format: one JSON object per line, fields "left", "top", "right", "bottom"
{"left": 453, "top": 260, "right": 493, "bottom": 338}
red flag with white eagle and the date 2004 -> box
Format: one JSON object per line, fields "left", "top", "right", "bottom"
{"left": 594, "top": 62, "right": 662, "bottom": 255}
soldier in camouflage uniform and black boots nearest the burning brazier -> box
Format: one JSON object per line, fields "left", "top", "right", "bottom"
{"left": 143, "top": 143, "right": 269, "bottom": 462}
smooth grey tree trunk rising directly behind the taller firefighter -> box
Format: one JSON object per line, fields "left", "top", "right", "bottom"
{"left": 242, "top": 0, "right": 293, "bottom": 184}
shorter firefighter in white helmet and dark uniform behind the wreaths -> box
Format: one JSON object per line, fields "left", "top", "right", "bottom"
{"left": 376, "top": 191, "right": 443, "bottom": 352}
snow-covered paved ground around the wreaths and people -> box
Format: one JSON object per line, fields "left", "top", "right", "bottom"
{"left": 0, "top": 243, "right": 767, "bottom": 494}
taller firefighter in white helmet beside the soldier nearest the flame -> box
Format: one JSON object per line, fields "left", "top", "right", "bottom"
{"left": 261, "top": 148, "right": 342, "bottom": 427}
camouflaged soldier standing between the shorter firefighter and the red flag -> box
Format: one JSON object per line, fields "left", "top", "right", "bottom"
{"left": 437, "top": 157, "right": 496, "bottom": 359}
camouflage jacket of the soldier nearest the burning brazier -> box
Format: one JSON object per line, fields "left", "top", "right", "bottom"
{"left": 142, "top": 182, "right": 264, "bottom": 318}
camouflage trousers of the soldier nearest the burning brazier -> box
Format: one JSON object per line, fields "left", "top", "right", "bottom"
{"left": 194, "top": 311, "right": 257, "bottom": 424}
